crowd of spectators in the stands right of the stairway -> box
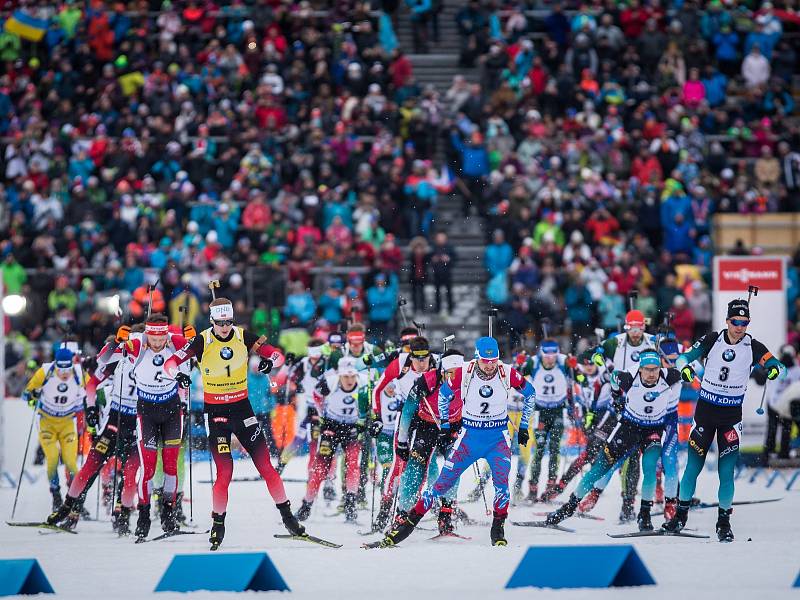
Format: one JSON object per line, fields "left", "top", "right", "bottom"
{"left": 434, "top": 0, "right": 800, "bottom": 346}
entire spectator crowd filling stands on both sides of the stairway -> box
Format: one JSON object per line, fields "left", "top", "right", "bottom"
{"left": 0, "top": 0, "right": 800, "bottom": 370}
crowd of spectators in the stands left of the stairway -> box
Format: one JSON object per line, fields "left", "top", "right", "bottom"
{"left": 0, "top": 0, "right": 462, "bottom": 360}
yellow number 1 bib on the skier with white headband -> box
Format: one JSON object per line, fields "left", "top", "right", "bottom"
{"left": 200, "top": 327, "right": 249, "bottom": 404}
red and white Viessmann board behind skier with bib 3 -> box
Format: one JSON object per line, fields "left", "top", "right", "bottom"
{"left": 713, "top": 256, "right": 787, "bottom": 353}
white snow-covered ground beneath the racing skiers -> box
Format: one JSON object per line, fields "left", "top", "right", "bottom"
{"left": 0, "top": 396, "right": 800, "bottom": 600}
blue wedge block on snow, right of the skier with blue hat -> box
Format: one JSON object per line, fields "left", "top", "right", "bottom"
{"left": 506, "top": 546, "right": 656, "bottom": 588}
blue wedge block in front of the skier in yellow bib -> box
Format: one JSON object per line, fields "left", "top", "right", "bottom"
{"left": 155, "top": 552, "right": 289, "bottom": 592}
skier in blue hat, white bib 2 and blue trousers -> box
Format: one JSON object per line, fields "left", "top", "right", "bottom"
{"left": 364, "top": 337, "right": 536, "bottom": 548}
